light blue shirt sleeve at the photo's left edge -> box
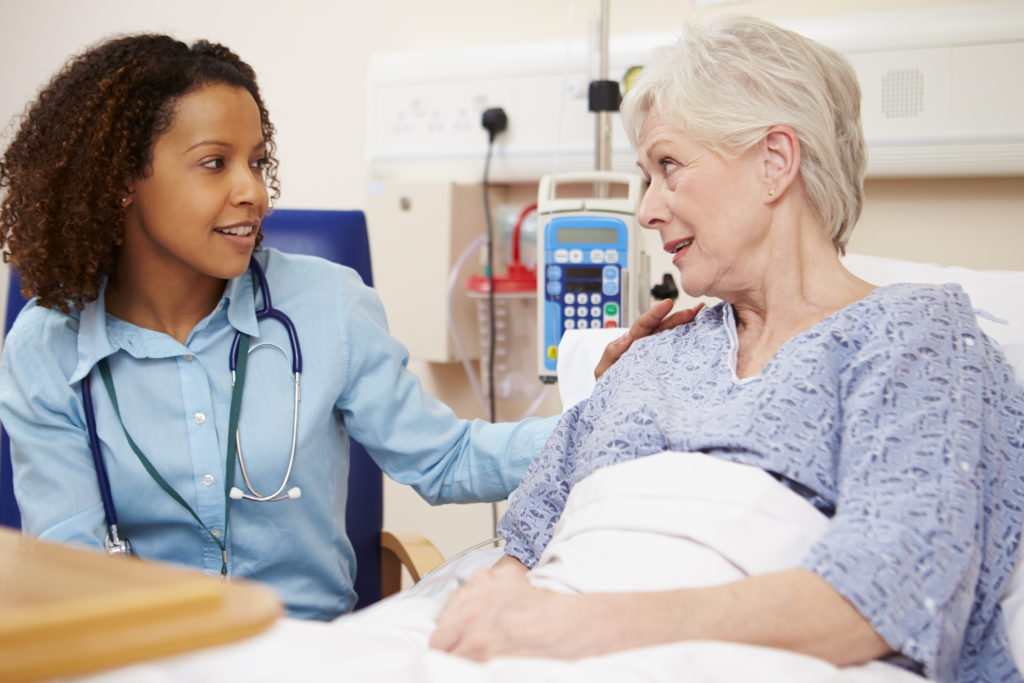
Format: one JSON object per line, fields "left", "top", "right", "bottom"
{"left": 0, "top": 308, "right": 105, "bottom": 548}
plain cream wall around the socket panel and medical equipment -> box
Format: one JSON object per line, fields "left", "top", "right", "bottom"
{"left": 0, "top": 0, "right": 1024, "bottom": 555}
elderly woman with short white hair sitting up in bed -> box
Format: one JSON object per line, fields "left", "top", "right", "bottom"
{"left": 431, "top": 18, "right": 1024, "bottom": 681}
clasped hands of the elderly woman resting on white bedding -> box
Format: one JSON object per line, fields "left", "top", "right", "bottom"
{"left": 430, "top": 557, "right": 608, "bottom": 661}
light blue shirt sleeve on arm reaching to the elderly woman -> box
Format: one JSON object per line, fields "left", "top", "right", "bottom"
{"left": 329, "top": 272, "right": 557, "bottom": 504}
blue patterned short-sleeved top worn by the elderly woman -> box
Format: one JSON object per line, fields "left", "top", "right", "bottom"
{"left": 499, "top": 285, "right": 1024, "bottom": 681}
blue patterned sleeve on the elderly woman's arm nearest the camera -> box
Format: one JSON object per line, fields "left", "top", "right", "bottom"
{"left": 804, "top": 296, "right": 999, "bottom": 680}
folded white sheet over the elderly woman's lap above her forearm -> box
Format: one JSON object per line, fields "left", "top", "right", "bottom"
{"left": 530, "top": 452, "right": 828, "bottom": 593}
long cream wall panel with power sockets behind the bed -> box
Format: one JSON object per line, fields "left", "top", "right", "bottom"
{"left": 368, "top": 0, "right": 1024, "bottom": 182}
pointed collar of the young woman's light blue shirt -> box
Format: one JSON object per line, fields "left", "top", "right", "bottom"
{"left": 68, "top": 269, "right": 259, "bottom": 384}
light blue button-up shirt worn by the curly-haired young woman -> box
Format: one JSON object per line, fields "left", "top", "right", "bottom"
{"left": 0, "top": 249, "right": 554, "bottom": 618}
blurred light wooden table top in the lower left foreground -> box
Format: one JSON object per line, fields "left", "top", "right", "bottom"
{"left": 0, "top": 527, "right": 282, "bottom": 681}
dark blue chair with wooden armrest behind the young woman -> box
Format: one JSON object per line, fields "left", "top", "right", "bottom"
{"left": 0, "top": 209, "right": 443, "bottom": 609}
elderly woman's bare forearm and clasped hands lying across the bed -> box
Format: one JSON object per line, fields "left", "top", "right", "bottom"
{"left": 430, "top": 557, "right": 892, "bottom": 667}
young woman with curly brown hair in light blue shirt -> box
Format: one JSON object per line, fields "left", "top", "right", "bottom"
{"left": 0, "top": 35, "right": 589, "bottom": 618}
